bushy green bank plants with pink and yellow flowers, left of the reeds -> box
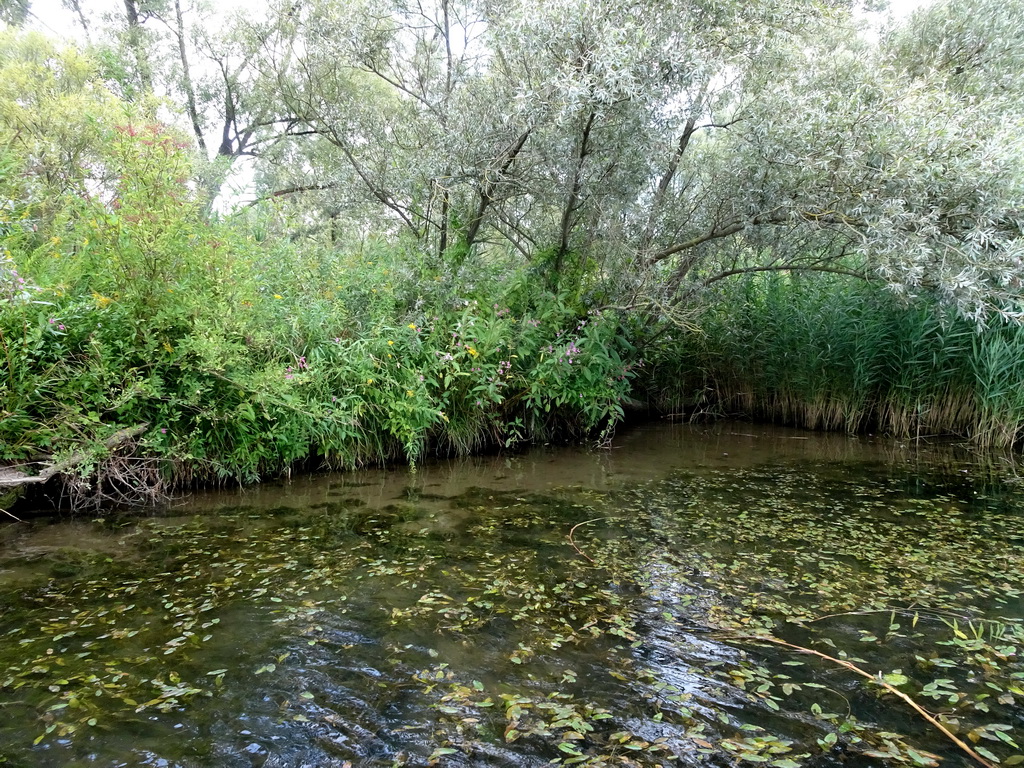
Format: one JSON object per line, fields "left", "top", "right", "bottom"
{"left": 0, "top": 46, "right": 631, "bottom": 490}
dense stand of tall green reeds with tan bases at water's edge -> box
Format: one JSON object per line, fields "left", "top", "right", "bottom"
{"left": 644, "top": 275, "right": 1024, "bottom": 447}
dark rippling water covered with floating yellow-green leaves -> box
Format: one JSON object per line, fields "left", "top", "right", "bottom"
{"left": 0, "top": 425, "right": 1024, "bottom": 768}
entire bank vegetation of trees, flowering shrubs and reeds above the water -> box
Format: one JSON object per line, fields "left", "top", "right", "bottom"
{"left": 0, "top": 0, "right": 1024, "bottom": 503}
